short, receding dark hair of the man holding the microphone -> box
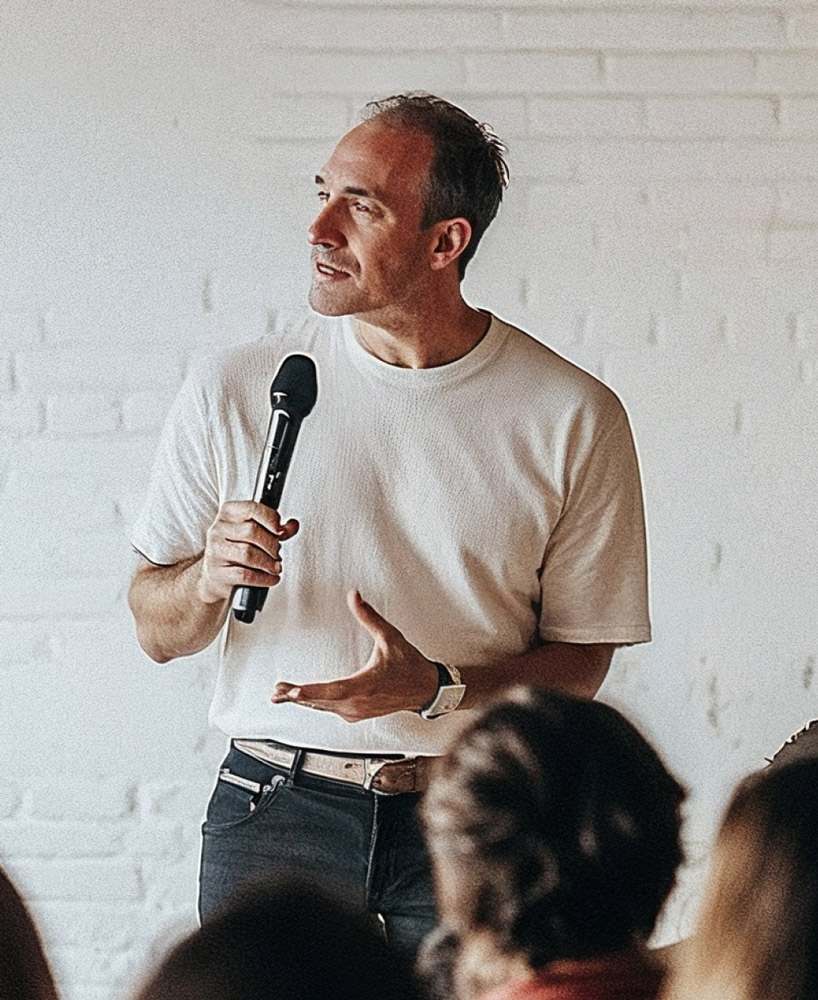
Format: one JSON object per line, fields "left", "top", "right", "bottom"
{"left": 364, "top": 92, "right": 508, "bottom": 279}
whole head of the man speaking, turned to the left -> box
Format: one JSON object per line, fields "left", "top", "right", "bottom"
{"left": 309, "top": 94, "right": 507, "bottom": 320}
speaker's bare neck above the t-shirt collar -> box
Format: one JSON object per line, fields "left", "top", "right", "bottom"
{"left": 353, "top": 298, "right": 491, "bottom": 376}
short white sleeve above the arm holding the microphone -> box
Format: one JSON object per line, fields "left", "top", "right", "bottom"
{"left": 131, "top": 374, "right": 219, "bottom": 566}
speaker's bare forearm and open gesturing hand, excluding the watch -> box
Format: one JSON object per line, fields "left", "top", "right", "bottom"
{"left": 271, "top": 591, "right": 615, "bottom": 722}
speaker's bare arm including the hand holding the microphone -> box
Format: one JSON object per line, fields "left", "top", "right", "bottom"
{"left": 128, "top": 500, "right": 298, "bottom": 663}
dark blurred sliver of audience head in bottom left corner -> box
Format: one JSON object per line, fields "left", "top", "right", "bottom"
{"left": 0, "top": 869, "right": 57, "bottom": 1000}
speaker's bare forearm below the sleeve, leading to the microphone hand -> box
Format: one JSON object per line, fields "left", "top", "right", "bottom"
{"left": 128, "top": 554, "right": 230, "bottom": 663}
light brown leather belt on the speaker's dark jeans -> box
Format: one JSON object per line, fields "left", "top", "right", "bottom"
{"left": 233, "top": 740, "right": 436, "bottom": 795}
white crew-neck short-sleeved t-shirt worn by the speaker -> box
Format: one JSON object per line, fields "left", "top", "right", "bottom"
{"left": 133, "top": 316, "right": 650, "bottom": 753}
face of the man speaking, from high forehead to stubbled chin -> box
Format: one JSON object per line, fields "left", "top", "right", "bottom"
{"left": 308, "top": 121, "right": 432, "bottom": 322}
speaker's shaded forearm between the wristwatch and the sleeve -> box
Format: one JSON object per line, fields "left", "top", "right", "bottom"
{"left": 458, "top": 642, "right": 615, "bottom": 708}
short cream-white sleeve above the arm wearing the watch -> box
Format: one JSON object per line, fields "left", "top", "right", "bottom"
{"left": 540, "top": 397, "right": 651, "bottom": 645}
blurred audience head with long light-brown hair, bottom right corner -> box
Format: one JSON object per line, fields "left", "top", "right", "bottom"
{"left": 671, "top": 757, "right": 818, "bottom": 1000}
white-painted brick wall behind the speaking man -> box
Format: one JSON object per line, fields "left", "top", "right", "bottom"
{"left": 0, "top": 0, "right": 818, "bottom": 1000}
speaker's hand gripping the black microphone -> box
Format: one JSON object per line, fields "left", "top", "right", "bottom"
{"left": 196, "top": 500, "right": 298, "bottom": 604}
